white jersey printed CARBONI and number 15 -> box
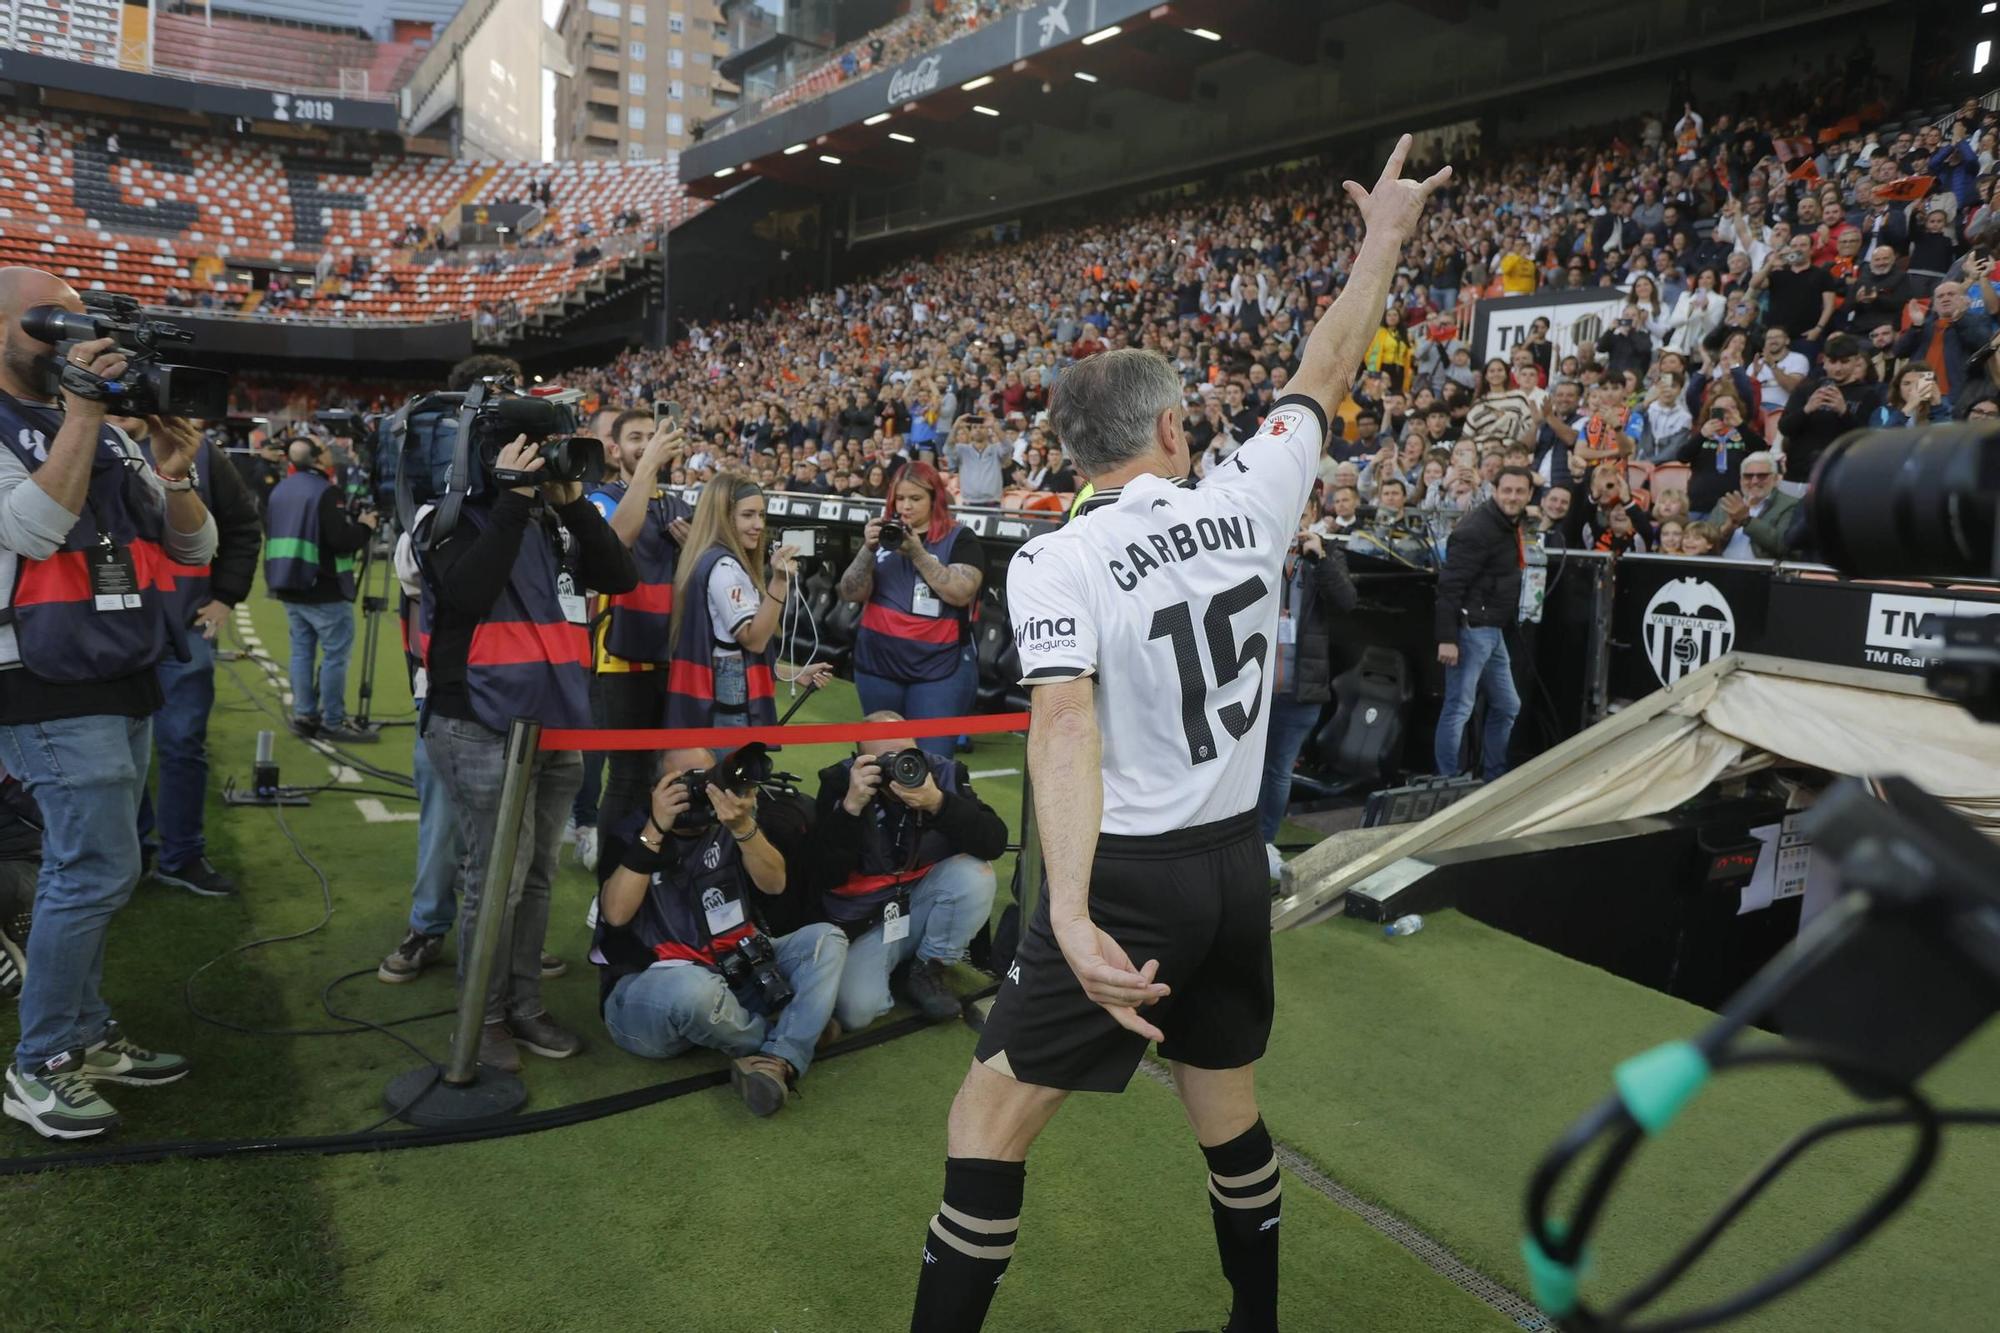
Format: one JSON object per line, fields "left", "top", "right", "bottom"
{"left": 1006, "top": 398, "right": 1326, "bottom": 835}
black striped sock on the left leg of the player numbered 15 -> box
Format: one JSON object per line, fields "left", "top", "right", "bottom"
{"left": 910, "top": 1157, "right": 1028, "bottom": 1333}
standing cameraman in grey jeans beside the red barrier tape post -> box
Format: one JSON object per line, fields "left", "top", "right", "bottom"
{"left": 414, "top": 434, "right": 638, "bottom": 1073}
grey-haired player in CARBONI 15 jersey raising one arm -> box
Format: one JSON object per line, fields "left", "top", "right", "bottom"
{"left": 910, "top": 136, "right": 1450, "bottom": 1333}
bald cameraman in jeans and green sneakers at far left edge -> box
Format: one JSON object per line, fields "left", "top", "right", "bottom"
{"left": 0, "top": 268, "right": 216, "bottom": 1139}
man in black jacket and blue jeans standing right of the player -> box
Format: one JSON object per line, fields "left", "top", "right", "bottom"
{"left": 1436, "top": 468, "right": 1534, "bottom": 781}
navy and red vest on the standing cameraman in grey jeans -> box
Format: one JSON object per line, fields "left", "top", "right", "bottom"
{"left": 416, "top": 504, "right": 592, "bottom": 733}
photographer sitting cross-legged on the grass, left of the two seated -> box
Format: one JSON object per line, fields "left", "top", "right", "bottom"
{"left": 590, "top": 751, "right": 848, "bottom": 1117}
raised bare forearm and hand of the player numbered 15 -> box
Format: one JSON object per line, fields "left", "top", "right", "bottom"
{"left": 1286, "top": 134, "right": 1452, "bottom": 416}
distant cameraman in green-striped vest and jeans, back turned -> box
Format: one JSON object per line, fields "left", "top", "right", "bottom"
{"left": 264, "top": 436, "right": 380, "bottom": 745}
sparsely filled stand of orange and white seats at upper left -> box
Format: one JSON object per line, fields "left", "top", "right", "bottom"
{"left": 0, "top": 112, "right": 698, "bottom": 324}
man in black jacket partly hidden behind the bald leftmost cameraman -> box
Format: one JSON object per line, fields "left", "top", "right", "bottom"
{"left": 110, "top": 416, "right": 264, "bottom": 899}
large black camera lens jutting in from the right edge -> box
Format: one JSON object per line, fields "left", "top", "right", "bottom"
{"left": 1806, "top": 424, "right": 2000, "bottom": 578}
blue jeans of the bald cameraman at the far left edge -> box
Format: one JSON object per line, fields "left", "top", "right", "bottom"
{"left": 0, "top": 717, "right": 152, "bottom": 1073}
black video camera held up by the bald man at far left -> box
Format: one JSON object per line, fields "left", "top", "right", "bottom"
{"left": 20, "top": 292, "right": 230, "bottom": 416}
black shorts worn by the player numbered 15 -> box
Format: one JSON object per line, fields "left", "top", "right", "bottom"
{"left": 974, "top": 811, "right": 1272, "bottom": 1093}
